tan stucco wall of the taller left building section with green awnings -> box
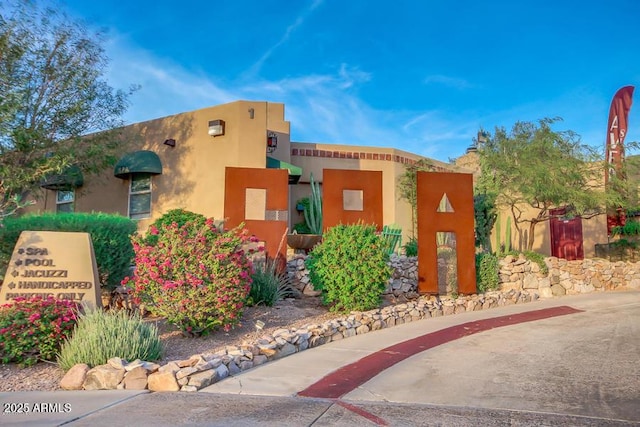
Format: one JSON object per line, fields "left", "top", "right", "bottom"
{"left": 29, "top": 101, "right": 290, "bottom": 231}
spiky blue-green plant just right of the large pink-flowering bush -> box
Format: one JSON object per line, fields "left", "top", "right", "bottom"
{"left": 248, "top": 258, "right": 294, "bottom": 307}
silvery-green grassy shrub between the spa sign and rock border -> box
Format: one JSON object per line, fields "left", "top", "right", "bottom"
{"left": 58, "top": 309, "right": 163, "bottom": 371}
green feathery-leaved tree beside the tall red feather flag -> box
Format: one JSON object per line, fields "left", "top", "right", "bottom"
{"left": 478, "top": 118, "right": 629, "bottom": 250}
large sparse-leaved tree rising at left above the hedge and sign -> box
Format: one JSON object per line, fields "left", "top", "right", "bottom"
{"left": 0, "top": 0, "right": 135, "bottom": 218}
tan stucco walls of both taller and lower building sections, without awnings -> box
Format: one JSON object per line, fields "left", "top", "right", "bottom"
{"left": 29, "top": 101, "right": 468, "bottom": 251}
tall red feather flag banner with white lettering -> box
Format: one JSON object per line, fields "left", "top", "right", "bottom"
{"left": 604, "top": 86, "right": 634, "bottom": 234}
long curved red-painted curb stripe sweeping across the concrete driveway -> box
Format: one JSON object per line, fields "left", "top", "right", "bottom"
{"left": 298, "top": 306, "right": 582, "bottom": 399}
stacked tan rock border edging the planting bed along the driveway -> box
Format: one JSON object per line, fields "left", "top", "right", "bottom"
{"left": 60, "top": 256, "right": 640, "bottom": 392}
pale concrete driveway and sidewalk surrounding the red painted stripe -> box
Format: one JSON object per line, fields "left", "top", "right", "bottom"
{"left": 0, "top": 291, "right": 640, "bottom": 426}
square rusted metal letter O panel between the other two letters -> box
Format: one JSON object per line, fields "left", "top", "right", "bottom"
{"left": 322, "top": 169, "right": 383, "bottom": 230}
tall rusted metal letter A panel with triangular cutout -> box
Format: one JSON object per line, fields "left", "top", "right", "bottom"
{"left": 417, "top": 172, "right": 476, "bottom": 294}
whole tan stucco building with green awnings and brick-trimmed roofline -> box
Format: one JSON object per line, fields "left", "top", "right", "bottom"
{"left": 30, "top": 101, "right": 466, "bottom": 251}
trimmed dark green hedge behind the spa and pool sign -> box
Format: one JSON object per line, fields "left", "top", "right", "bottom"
{"left": 0, "top": 213, "right": 137, "bottom": 290}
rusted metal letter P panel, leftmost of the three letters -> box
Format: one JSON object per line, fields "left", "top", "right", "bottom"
{"left": 224, "top": 167, "right": 289, "bottom": 258}
